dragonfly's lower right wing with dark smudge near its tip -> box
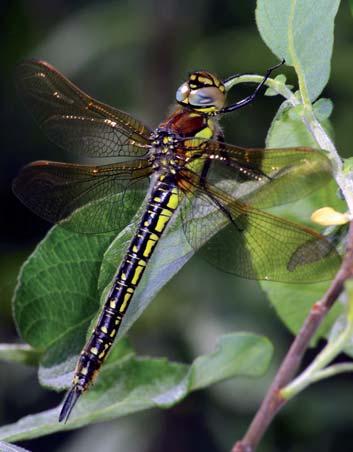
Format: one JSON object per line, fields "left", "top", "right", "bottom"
{"left": 181, "top": 170, "right": 340, "bottom": 282}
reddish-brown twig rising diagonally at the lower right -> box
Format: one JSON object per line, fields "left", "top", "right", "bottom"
{"left": 232, "top": 222, "right": 353, "bottom": 452}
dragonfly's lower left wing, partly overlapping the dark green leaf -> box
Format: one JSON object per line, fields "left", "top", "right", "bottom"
{"left": 13, "top": 160, "right": 151, "bottom": 233}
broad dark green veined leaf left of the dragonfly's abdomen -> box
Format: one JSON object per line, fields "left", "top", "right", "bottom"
{"left": 14, "top": 226, "right": 114, "bottom": 388}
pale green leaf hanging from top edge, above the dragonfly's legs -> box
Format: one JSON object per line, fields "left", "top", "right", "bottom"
{"left": 256, "top": 0, "right": 340, "bottom": 100}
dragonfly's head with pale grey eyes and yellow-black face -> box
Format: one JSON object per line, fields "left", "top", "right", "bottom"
{"left": 176, "top": 71, "right": 226, "bottom": 115}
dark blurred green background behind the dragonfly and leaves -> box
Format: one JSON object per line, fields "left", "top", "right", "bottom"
{"left": 0, "top": 0, "right": 353, "bottom": 452}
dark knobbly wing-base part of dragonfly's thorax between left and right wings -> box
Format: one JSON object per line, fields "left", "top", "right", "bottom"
{"left": 150, "top": 129, "right": 183, "bottom": 174}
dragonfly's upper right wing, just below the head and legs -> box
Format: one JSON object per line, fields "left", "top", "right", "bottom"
{"left": 183, "top": 139, "right": 332, "bottom": 208}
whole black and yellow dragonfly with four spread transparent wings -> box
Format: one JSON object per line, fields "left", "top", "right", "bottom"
{"left": 13, "top": 60, "right": 340, "bottom": 422}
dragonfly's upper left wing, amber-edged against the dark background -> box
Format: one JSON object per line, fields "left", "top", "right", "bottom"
{"left": 16, "top": 60, "right": 151, "bottom": 157}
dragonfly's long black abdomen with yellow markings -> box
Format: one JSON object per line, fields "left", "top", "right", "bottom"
{"left": 60, "top": 175, "right": 179, "bottom": 420}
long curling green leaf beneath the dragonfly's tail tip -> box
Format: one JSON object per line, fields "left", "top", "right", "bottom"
{"left": 0, "top": 333, "right": 272, "bottom": 441}
